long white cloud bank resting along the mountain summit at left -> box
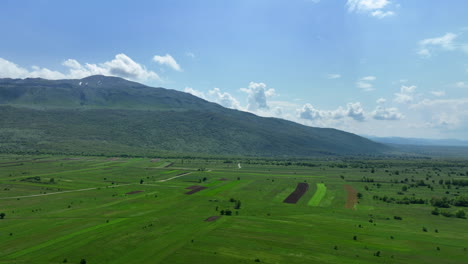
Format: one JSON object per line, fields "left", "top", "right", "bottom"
{"left": 0, "top": 53, "right": 160, "bottom": 81}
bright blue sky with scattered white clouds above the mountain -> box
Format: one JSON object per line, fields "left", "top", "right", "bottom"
{"left": 0, "top": 0, "right": 468, "bottom": 139}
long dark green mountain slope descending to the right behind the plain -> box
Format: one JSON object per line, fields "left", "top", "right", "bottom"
{"left": 0, "top": 76, "right": 388, "bottom": 156}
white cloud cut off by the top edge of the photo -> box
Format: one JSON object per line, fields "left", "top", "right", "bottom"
{"left": 346, "top": 0, "right": 395, "bottom": 19}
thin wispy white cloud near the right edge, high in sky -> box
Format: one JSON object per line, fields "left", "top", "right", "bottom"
{"left": 417, "top": 32, "right": 458, "bottom": 58}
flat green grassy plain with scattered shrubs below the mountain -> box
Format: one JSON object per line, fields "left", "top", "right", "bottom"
{"left": 0, "top": 155, "right": 468, "bottom": 264}
